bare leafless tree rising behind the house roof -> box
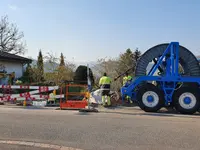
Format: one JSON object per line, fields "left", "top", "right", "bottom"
{"left": 0, "top": 16, "right": 25, "bottom": 54}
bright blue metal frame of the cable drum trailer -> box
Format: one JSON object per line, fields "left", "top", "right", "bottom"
{"left": 121, "top": 42, "right": 200, "bottom": 105}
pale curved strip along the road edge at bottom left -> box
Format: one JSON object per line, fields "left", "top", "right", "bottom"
{"left": 0, "top": 140, "right": 83, "bottom": 150}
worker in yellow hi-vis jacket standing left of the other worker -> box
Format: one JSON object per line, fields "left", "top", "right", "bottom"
{"left": 99, "top": 73, "right": 111, "bottom": 106}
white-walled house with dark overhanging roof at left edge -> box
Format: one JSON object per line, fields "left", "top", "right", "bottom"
{"left": 0, "top": 52, "right": 32, "bottom": 78}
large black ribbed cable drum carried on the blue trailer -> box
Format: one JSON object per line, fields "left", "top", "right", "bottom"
{"left": 135, "top": 43, "right": 200, "bottom": 77}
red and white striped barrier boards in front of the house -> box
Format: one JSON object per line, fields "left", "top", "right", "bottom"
{"left": 0, "top": 85, "right": 64, "bottom": 101}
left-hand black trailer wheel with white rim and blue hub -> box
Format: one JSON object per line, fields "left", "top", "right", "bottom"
{"left": 137, "top": 83, "right": 164, "bottom": 112}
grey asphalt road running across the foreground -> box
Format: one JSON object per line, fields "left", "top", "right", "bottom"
{"left": 0, "top": 107, "right": 200, "bottom": 150}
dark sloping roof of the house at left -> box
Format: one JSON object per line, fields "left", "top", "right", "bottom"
{"left": 0, "top": 52, "right": 32, "bottom": 63}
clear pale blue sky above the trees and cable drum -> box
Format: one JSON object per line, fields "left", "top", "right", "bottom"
{"left": 0, "top": 0, "right": 200, "bottom": 63}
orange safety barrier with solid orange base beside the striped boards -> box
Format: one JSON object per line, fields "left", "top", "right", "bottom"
{"left": 60, "top": 84, "right": 88, "bottom": 109}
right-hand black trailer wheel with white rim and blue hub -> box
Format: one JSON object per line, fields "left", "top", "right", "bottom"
{"left": 173, "top": 87, "right": 200, "bottom": 114}
